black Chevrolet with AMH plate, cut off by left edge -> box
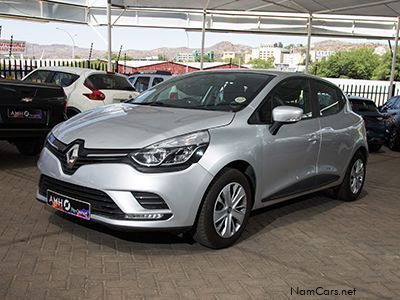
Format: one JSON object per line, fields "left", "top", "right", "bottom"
{"left": 0, "top": 79, "right": 66, "bottom": 155}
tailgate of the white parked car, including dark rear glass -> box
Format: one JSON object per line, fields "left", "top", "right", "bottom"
{"left": 86, "top": 74, "right": 137, "bottom": 104}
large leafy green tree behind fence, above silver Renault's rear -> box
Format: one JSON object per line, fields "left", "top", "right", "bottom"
{"left": 310, "top": 47, "right": 380, "bottom": 79}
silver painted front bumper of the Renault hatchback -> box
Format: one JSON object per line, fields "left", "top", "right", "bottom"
{"left": 36, "top": 148, "right": 213, "bottom": 230}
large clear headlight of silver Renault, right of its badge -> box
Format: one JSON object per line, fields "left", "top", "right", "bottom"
{"left": 131, "top": 131, "right": 210, "bottom": 168}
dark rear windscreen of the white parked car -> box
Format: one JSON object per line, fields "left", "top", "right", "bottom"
{"left": 86, "top": 74, "right": 135, "bottom": 91}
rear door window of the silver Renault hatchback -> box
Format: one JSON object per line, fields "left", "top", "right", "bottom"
{"left": 314, "top": 81, "right": 344, "bottom": 116}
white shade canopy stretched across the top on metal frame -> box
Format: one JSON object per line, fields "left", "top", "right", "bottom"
{"left": 0, "top": 0, "right": 400, "bottom": 39}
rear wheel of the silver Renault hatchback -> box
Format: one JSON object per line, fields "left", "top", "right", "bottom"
{"left": 335, "top": 152, "right": 367, "bottom": 202}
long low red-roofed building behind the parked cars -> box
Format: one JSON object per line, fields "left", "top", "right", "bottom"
{"left": 114, "top": 60, "right": 239, "bottom": 74}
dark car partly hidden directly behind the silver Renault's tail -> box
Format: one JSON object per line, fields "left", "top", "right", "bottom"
{"left": 348, "top": 96, "right": 386, "bottom": 152}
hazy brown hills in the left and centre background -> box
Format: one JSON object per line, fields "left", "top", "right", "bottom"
{"left": 24, "top": 41, "right": 252, "bottom": 59}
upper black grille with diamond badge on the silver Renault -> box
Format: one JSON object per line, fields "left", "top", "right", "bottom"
{"left": 45, "top": 139, "right": 130, "bottom": 175}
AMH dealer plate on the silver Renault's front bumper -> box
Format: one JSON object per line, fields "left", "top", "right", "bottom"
{"left": 47, "top": 190, "right": 90, "bottom": 220}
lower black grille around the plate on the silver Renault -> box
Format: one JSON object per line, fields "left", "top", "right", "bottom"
{"left": 39, "top": 175, "right": 125, "bottom": 219}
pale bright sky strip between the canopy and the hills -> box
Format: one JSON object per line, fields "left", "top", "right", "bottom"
{"left": 0, "top": 18, "right": 382, "bottom": 51}
